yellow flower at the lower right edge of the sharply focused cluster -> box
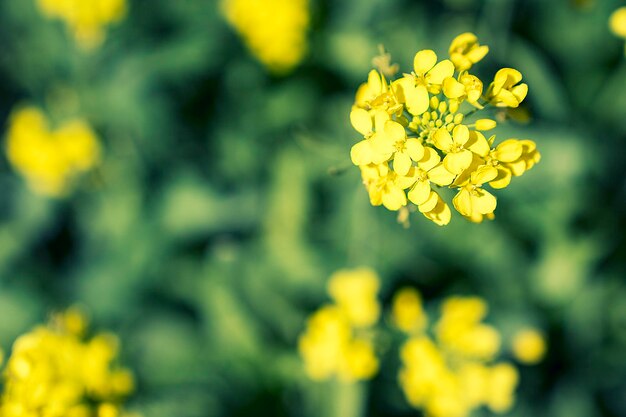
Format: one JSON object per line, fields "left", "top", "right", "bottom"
{"left": 452, "top": 165, "right": 498, "bottom": 221}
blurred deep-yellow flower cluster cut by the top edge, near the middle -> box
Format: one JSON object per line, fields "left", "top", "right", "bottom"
{"left": 222, "top": 0, "right": 310, "bottom": 74}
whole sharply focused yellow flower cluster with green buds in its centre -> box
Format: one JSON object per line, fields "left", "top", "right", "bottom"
{"left": 350, "top": 33, "right": 540, "bottom": 225}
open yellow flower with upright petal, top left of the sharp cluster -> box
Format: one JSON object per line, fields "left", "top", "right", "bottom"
{"left": 396, "top": 49, "right": 454, "bottom": 116}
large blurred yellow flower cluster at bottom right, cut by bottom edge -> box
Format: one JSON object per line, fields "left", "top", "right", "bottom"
{"left": 392, "top": 289, "right": 518, "bottom": 417}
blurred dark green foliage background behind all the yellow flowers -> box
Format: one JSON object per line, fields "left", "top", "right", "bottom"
{"left": 0, "top": 0, "right": 626, "bottom": 417}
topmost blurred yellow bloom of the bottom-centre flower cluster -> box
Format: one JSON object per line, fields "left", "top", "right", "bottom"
{"left": 328, "top": 268, "right": 380, "bottom": 327}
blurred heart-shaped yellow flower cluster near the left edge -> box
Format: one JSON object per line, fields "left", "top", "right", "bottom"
{"left": 7, "top": 107, "right": 100, "bottom": 196}
